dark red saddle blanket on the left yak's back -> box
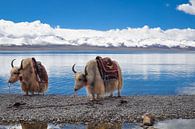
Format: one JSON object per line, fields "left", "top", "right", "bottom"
{"left": 32, "top": 58, "right": 48, "bottom": 83}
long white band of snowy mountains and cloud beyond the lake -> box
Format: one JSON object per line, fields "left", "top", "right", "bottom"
{"left": 0, "top": 20, "right": 195, "bottom": 48}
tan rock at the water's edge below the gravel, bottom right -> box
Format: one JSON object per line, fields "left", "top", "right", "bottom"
{"left": 142, "top": 113, "right": 155, "bottom": 126}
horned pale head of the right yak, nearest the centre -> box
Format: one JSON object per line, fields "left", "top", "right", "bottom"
{"left": 72, "top": 64, "right": 87, "bottom": 92}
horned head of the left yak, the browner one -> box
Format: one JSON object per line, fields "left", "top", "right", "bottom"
{"left": 8, "top": 59, "right": 23, "bottom": 83}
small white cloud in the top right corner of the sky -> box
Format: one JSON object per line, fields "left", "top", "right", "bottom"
{"left": 177, "top": 0, "right": 195, "bottom": 15}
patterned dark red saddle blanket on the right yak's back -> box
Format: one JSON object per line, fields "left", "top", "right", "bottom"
{"left": 96, "top": 56, "right": 119, "bottom": 80}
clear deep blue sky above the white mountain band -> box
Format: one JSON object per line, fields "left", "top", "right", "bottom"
{"left": 0, "top": 0, "right": 195, "bottom": 30}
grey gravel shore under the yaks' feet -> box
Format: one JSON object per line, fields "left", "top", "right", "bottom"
{"left": 0, "top": 94, "right": 195, "bottom": 123}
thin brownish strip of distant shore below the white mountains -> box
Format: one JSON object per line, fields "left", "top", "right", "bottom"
{"left": 0, "top": 45, "right": 195, "bottom": 51}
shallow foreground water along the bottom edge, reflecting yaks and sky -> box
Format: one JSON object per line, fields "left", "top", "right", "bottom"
{"left": 0, "top": 119, "right": 195, "bottom": 129}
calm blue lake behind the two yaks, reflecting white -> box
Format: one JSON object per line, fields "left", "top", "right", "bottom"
{"left": 0, "top": 50, "right": 195, "bottom": 95}
